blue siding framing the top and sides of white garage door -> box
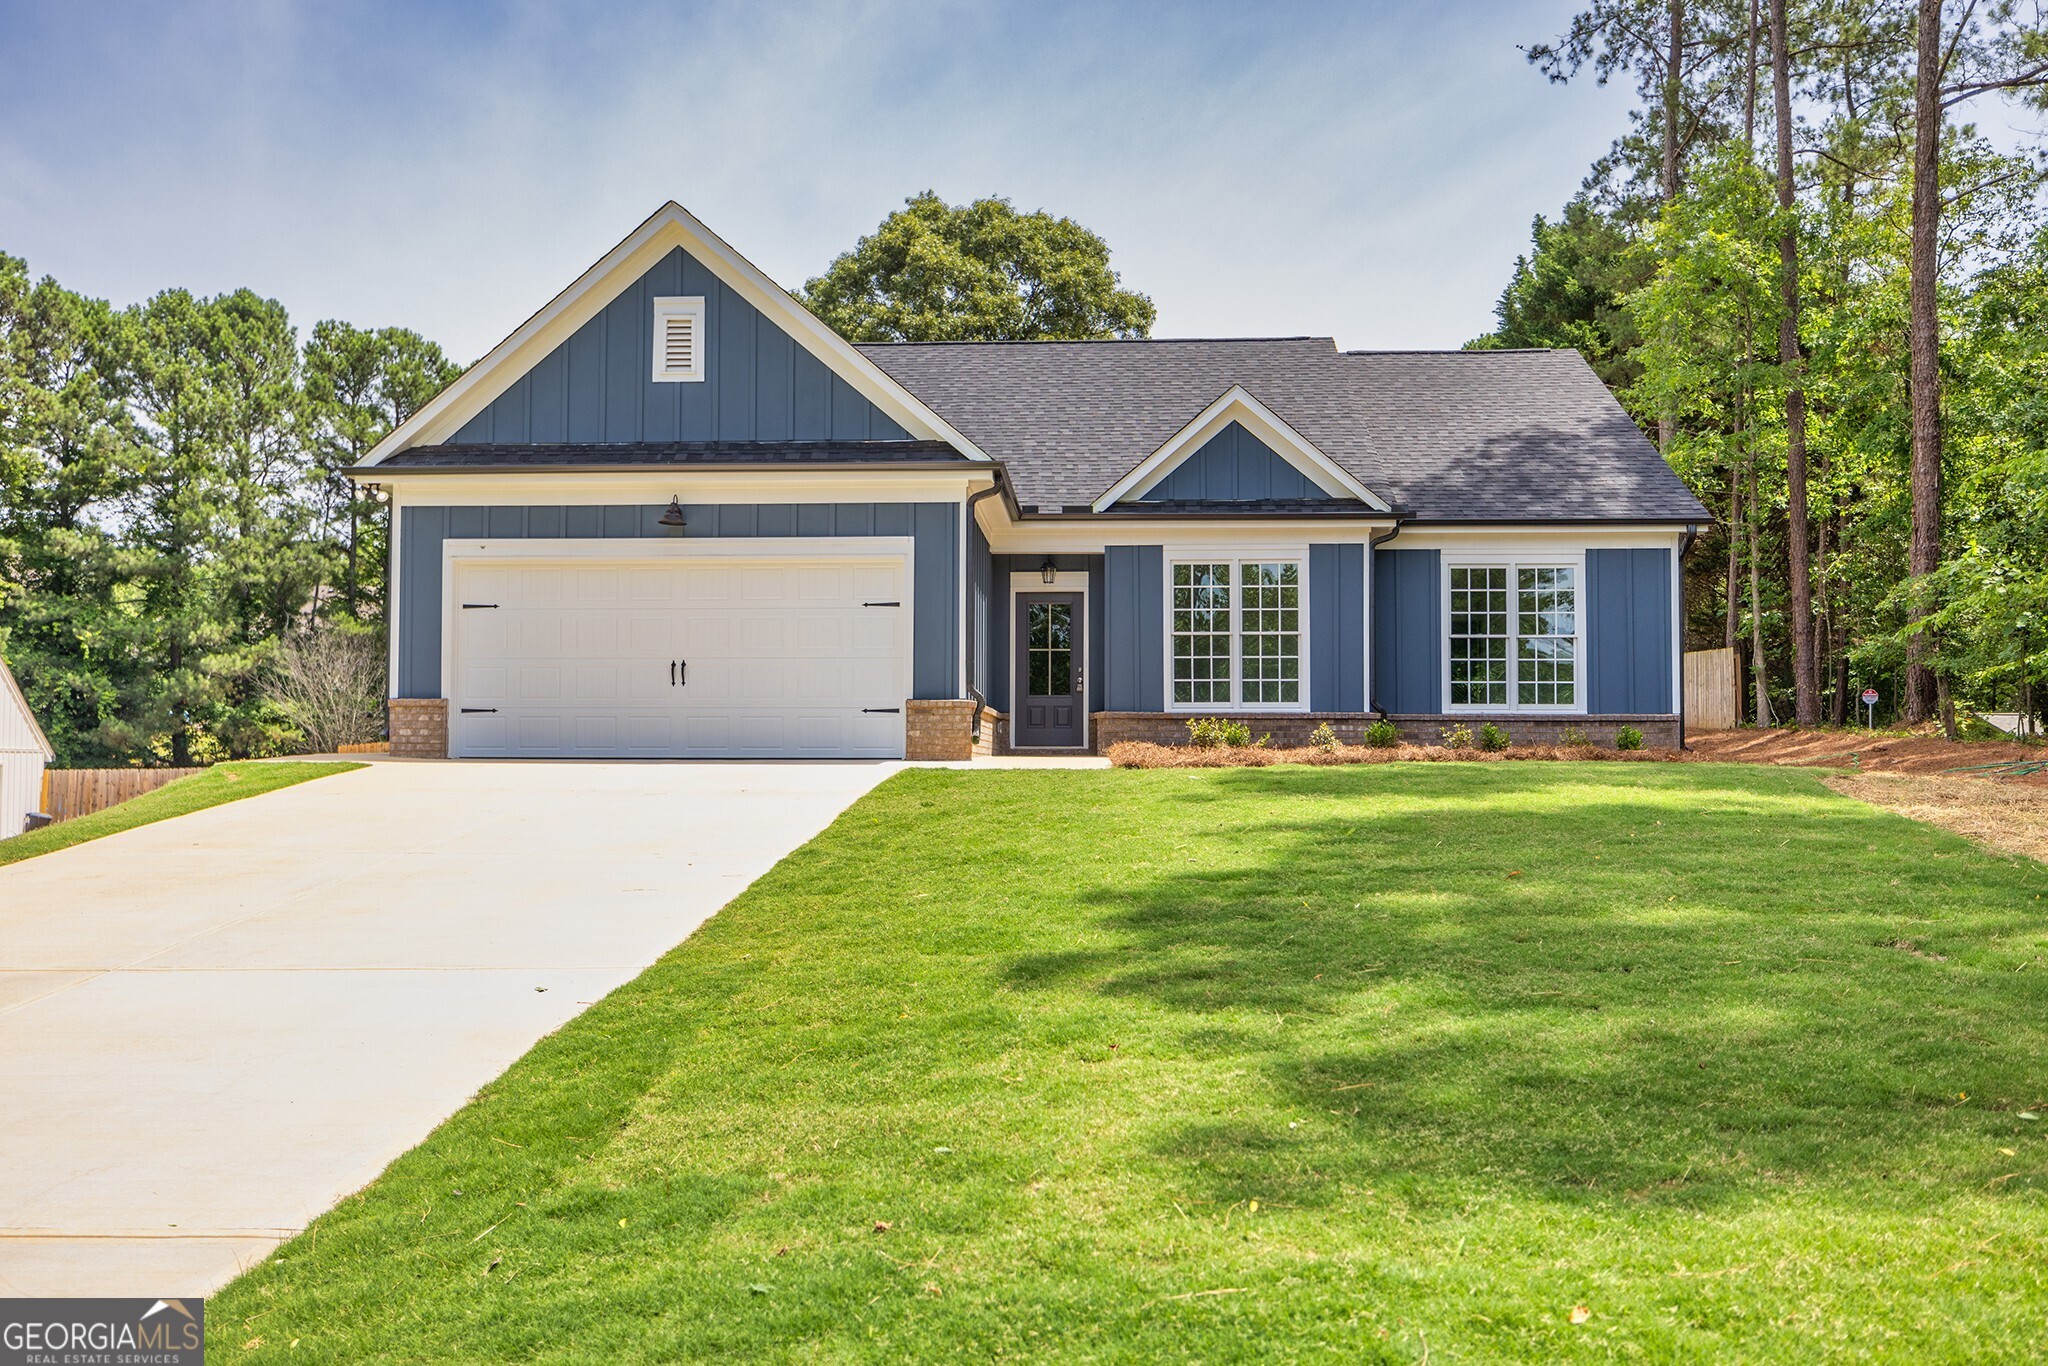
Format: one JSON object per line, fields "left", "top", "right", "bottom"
{"left": 395, "top": 502, "right": 961, "bottom": 698}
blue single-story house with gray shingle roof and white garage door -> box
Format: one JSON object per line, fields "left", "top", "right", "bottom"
{"left": 352, "top": 203, "right": 1708, "bottom": 758}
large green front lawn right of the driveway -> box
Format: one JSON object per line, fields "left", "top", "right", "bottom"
{"left": 207, "top": 764, "right": 2048, "bottom": 1362}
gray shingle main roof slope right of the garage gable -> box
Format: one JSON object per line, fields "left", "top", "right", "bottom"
{"left": 860, "top": 338, "right": 1708, "bottom": 522}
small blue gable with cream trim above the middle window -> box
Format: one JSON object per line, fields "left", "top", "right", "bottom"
{"left": 1094, "top": 385, "right": 1389, "bottom": 512}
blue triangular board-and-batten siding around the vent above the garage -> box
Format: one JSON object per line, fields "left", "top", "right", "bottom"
{"left": 453, "top": 248, "right": 909, "bottom": 444}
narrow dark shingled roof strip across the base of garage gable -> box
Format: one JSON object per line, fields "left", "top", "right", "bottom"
{"left": 372, "top": 440, "right": 985, "bottom": 479}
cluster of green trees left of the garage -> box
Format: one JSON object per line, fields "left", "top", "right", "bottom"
{"left": 0, "top": 256, "right": 457, "bottom": 766}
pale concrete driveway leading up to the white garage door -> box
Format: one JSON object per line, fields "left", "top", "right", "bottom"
{"left": 0, "top": 762, "right": 897, "bottom": 1296}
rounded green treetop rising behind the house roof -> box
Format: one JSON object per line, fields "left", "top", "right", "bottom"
{"left": 801, "top": 190, "right": 1155, "bottom": 342}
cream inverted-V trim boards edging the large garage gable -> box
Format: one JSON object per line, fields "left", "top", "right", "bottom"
{"left": 356, "top": 201, "right": 989, "bottom": 469}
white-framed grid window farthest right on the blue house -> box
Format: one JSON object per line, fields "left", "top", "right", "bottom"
{"left": 1444, "top": 561, "right": 1585, "bottom": 711}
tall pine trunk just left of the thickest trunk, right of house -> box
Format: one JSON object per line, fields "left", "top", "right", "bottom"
{"left": 1772, "top": 0, "right": 1821, "bottom": 727}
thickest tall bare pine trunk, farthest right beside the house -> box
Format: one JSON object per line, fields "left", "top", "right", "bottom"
{"left": 1907, "top": 0, "right": 1942, "bottom": 725}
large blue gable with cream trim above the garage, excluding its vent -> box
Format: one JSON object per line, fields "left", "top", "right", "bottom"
{"left": 362, "top": 203, "right": 987, "bottom": 465}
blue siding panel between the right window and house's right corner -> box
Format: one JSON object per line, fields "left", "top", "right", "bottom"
{"left": 1581, "top": 549, "right": 1673, "bottom": 715}
